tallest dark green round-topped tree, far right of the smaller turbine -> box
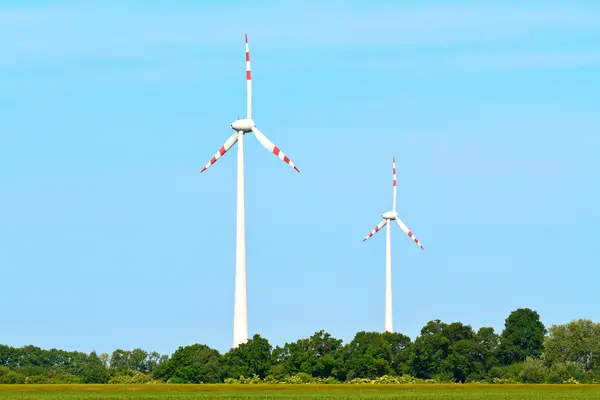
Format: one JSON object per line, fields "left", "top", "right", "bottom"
{"left": 498, "top": 308, "right": 546, "bottom": 365}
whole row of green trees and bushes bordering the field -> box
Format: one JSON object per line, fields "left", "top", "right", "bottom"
{"left": 0, "top": 308, "right": 600, "bottom": 384}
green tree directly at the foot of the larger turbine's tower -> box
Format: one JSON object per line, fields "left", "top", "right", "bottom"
{"left": 223, "top": 334, "right": 272, "bottom": 379}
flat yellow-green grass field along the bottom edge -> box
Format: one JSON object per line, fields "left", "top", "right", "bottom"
{"left": 0, "top": 385, "right": 600, "bottom": 400}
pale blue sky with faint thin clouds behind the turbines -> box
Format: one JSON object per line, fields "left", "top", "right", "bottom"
{"left": 0, "top": 1, "right": 600, "bottom": 353}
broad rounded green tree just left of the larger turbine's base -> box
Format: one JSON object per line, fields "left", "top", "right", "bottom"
{"left": 154, "top": 344, "right": 221, "bottom": 383}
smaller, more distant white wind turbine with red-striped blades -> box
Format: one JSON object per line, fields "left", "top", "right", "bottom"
{"left": 363, "top": 157, "right": 425, "bottom": 332}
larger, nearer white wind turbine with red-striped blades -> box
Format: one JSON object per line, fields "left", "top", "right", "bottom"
{"left": 200, "top": 35, "right": 300, "bottom": 347}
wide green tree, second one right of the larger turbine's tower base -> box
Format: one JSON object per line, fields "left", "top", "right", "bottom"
{"left": 273, "top": 330, "right": 343, "bottom": 379}
